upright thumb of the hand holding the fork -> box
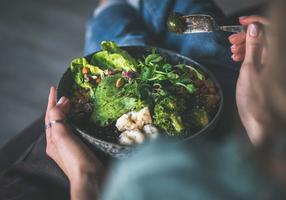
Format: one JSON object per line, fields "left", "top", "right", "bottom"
{"left": 244, "top": 24, "right": 264, "bottom": 66}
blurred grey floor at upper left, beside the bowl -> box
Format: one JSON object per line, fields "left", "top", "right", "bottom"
{"left": 0, "top": 0, "right": 97, "bottom": 146}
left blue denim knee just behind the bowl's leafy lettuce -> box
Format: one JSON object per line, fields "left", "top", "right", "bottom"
{"left": 85, "top": 3, "right": 153, "bottom": 54}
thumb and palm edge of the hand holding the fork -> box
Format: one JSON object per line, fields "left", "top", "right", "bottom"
{"left": 236, "top": 24, "right": 270, "bottom": 145}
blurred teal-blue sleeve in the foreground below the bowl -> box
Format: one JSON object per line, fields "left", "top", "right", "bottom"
{"left": 102, "top": 138, "right": 278, "bottom": 200}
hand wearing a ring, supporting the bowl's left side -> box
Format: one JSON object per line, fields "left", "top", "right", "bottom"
{"left": 45, "top": 87, "right": 104, "bottom": 199}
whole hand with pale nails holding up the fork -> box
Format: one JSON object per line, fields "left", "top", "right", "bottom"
{"left": 230, "top": 16, "right": 274, "bottom": 145}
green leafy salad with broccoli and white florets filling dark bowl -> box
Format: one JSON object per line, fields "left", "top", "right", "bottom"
{"left": 58, "top": 41, "right": 222, "bottom": 156}
